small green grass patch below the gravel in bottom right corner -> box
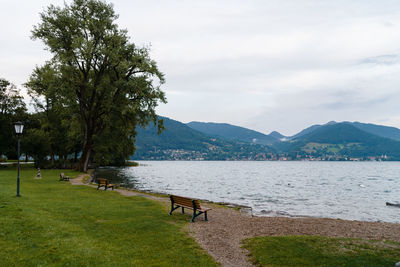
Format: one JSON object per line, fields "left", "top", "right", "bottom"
{"left": 244, "top": 236, "right": 400, "bottom": 267}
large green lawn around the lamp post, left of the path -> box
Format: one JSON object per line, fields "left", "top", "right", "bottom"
{"left": 0, "top": 166, "right": 217, "bottom": 266}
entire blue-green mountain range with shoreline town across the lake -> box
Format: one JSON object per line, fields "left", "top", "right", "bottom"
{"left": 133, "top": 118, "right": 400, "bottom": 160}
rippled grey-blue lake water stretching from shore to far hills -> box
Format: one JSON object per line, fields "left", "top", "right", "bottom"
{"left": 96, "top": 161, "right": 400, "bottom": 223}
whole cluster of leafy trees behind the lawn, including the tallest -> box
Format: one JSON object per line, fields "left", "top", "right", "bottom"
{"left": 0, "top": 0, "right": 166, "bottom": 171}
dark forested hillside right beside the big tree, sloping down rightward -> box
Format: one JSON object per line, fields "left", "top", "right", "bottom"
{"left": 132, "top": 117, "right": 272, "bottom": 160}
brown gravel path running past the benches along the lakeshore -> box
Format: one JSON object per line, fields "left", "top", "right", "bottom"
{"left": 71, "top": 175, "right": 400, "bottom": 267}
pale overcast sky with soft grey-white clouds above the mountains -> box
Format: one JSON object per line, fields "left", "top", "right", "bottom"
{"left": 0, "top": 0, "right": 400, "bottom": 135}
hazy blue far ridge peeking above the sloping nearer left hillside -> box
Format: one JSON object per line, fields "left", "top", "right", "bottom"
{"left": 186, "top": 121, "right": 279, "bottom": 145}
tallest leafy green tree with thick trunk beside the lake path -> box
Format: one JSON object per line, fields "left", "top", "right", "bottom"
{"left": 28, "top": 0, "right": 166, "bottom": 171}
